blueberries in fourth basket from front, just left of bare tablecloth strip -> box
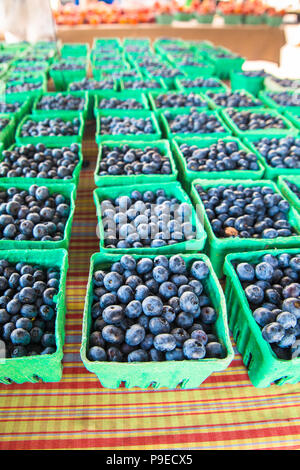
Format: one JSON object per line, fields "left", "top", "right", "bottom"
{"left": 20, "top": 117, "right": 80, "bottom": 137}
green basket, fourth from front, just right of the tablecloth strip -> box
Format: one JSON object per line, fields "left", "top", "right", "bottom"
{"left": 96, "top": 109, "right": 161, "bottom": 144}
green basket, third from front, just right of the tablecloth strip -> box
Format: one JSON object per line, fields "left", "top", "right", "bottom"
{"left": 94, "top": 140, "right": 178, "bottom": 187}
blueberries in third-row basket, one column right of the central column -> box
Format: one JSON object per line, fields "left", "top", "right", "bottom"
{"left": 179, "top": 139, "right": 259, "bottom": 171}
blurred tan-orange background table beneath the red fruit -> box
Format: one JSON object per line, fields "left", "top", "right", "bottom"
{"left": 57, "top": 22, "right": 286, "bottom": 64}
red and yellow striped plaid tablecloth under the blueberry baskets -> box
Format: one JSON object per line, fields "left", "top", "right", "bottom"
{"left": 0, "top": 125, "right": 300, "bottom": 450}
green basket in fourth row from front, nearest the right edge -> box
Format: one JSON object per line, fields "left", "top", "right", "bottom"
{"left": 220, "top": 107, "right": 297, "bottom": 138}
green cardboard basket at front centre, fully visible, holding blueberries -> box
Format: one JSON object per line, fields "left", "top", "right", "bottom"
{"left": 80, "top": 253, "right": 234, "bottom": 389}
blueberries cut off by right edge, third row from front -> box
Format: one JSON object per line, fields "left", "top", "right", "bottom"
{"left": 253, "top": 136, "right": 300, "bottom": 169}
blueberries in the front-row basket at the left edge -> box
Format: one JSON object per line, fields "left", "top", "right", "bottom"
{"left": 0, "top": 259, "right": 60, "bottom": 358}
